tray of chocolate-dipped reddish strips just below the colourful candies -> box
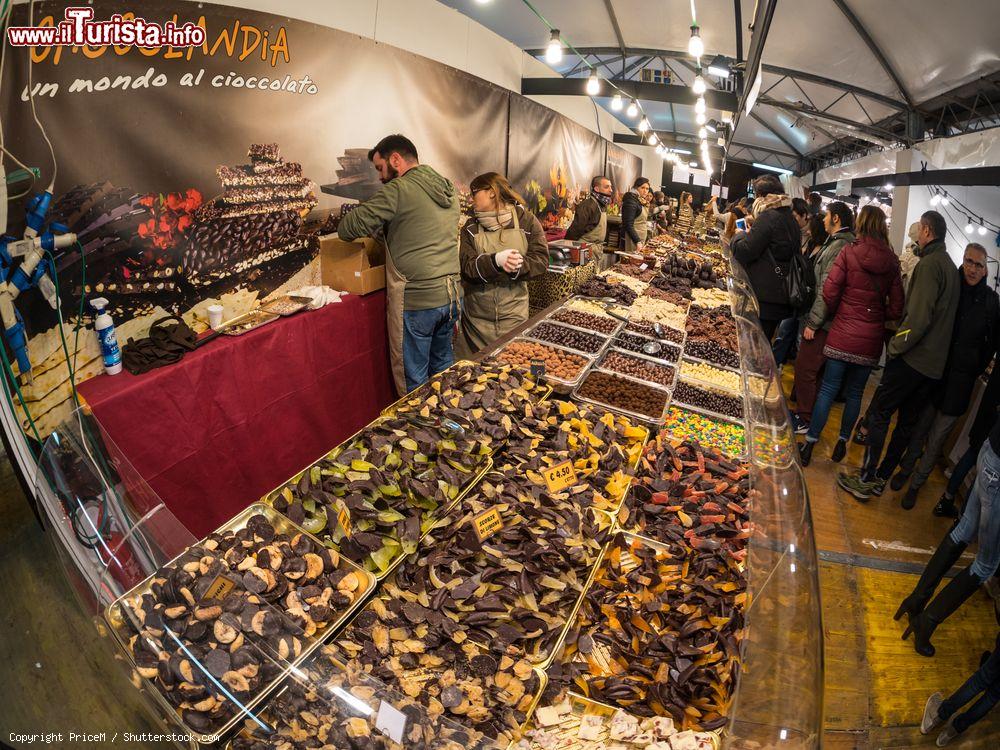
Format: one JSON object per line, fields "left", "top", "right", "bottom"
{"left": 618, "top": 435, "right": 752, "bottom": 563}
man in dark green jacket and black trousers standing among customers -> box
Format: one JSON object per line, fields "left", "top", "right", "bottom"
{"left": 837, "top": 211, "right": 960, "bottom": 502}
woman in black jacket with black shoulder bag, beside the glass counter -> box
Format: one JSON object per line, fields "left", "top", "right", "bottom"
{"left": 730, "top": 175, "right": 802, "bottom": 340}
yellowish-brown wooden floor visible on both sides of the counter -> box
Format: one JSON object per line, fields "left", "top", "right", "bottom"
{"left": 0, "top": 368, "right": 1000, "bottom": 750}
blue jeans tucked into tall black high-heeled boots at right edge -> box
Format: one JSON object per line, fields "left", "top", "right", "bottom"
{"left": 951, "top": 440, "right": 1000, "bottom": 583}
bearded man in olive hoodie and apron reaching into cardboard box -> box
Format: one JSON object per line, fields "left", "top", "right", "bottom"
{"left": 337, "top": 135, "right": 462, "bottom": 392}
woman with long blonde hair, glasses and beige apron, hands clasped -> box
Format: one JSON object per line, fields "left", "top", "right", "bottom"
{"left": 456, "top": 172, "right": 549, "bottom": 357}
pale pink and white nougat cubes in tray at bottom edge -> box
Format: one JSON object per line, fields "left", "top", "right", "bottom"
{"left": 510, "top": 691, "right": 721, "bottom": 750}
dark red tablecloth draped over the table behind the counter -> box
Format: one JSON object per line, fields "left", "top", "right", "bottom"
{"left": 79, "top": 292, "right": 395, "bottom": 538}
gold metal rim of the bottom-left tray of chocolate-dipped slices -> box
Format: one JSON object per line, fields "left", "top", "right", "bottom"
{"left": 104, "top": 503, "right": 376, "bottom": 744}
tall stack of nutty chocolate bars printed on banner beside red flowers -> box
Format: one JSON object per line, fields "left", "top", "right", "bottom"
{"left": 183, "top": 143, "right": 316, "bottom": 285}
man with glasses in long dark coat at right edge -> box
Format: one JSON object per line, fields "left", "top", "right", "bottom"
{"left": 889, "top": 242, "right": 1000, "bottom": 510}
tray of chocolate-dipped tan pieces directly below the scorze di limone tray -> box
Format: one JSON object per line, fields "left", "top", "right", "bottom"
{"left": 331, "top": 587, "right": 548, "bottom": 747}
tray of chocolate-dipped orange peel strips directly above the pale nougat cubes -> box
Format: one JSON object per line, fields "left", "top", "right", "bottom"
{"left": 558, "top": 533, "right": 747, "bottom": 732}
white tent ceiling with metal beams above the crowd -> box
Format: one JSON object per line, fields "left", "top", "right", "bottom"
{"left": 441, "top": 0, "right": 1000, "bottom": 170}
